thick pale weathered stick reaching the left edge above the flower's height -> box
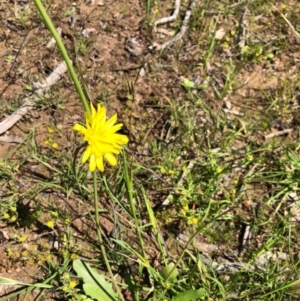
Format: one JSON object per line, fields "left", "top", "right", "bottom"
{"left": 0, "top": 62, "right": 67, "bottom": 135}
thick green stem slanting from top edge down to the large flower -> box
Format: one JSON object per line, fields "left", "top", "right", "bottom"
{"left": 34, "top": 0, "right": 91, "bottom": 115}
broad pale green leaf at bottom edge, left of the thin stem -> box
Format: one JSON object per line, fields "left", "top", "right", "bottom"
{"left": 73, "top": 259, "right": 118, "bottom": 301}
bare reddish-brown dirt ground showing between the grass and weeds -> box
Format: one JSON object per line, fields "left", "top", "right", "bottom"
{"left": 0, "top": 0, "right": 300, "bottom": 300}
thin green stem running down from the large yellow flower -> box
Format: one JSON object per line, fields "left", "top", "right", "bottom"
{"left": 93, "top": 171, "right": 124, "bottom": 301}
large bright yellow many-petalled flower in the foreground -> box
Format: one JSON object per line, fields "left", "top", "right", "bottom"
{"left": 73, "top": 104, "right": 128, "bottom": 171}
